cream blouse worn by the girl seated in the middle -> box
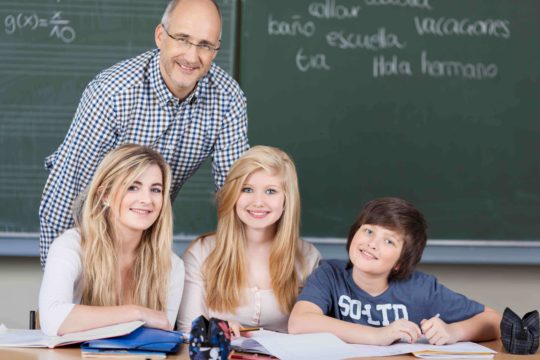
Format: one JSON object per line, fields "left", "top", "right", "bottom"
{"left": 178, "top": 236, "right": 321, "bottom": 332}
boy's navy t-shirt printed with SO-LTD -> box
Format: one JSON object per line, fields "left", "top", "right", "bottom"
{"left": 297, "top": 260, "right": 484, "bottom": 326}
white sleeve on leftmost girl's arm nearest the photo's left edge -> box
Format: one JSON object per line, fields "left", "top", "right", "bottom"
{"left": 39, "top": 229, "right": 82, "bottom": 336}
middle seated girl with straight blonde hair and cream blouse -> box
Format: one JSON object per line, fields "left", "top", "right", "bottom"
{"left": 178, "top": 146, "right": 320, "bottom": 335}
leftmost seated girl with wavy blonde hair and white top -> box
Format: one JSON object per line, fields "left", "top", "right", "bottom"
{"left": 39, "top": 144, "right": 184, "bottom": 335}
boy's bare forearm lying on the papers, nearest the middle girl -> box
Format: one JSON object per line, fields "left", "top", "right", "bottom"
{"left": 289, "top": 301, "right": 420, "bottom": 345}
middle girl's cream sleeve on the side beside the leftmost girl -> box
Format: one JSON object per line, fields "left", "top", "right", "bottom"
{"left": 178, "top": 239, "right": 208, "bottom": 333}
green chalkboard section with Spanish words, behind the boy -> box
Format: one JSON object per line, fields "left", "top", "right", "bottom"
{"left": 240, "top": 0, "right": 540, "bottom": 240}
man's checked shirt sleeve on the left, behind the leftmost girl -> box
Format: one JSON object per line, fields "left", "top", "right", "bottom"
{"left": 39, "top": 81, "right": 115, "bottom": 267}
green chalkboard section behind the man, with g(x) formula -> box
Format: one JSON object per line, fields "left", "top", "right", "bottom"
{"left": 0, "top": 0, "right": 236, "bottom": 239}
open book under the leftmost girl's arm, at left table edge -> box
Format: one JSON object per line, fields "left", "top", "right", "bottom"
{"left": 0, "top": 321, "right": 144, "bottom": 349}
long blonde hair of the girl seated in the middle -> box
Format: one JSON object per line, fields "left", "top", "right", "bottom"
{"left": 203, "top": 146, "right": 304, "bottom": 314}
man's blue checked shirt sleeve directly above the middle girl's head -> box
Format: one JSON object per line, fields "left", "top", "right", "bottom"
{"left": 212, "top": 90, "right": 249, "bottom": 190}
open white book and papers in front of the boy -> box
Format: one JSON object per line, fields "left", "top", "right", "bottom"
{"left": 232, "top": 330, "right": 496, "bottom": 360}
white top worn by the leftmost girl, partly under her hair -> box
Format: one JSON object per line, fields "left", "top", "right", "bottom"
{"left": 39, "top": 229, "right": 184, "bottom": 336}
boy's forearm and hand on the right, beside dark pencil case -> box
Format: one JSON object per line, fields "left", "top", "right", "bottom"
{"left": 421, "top": 307, "right": 501, "bottom": 345}
